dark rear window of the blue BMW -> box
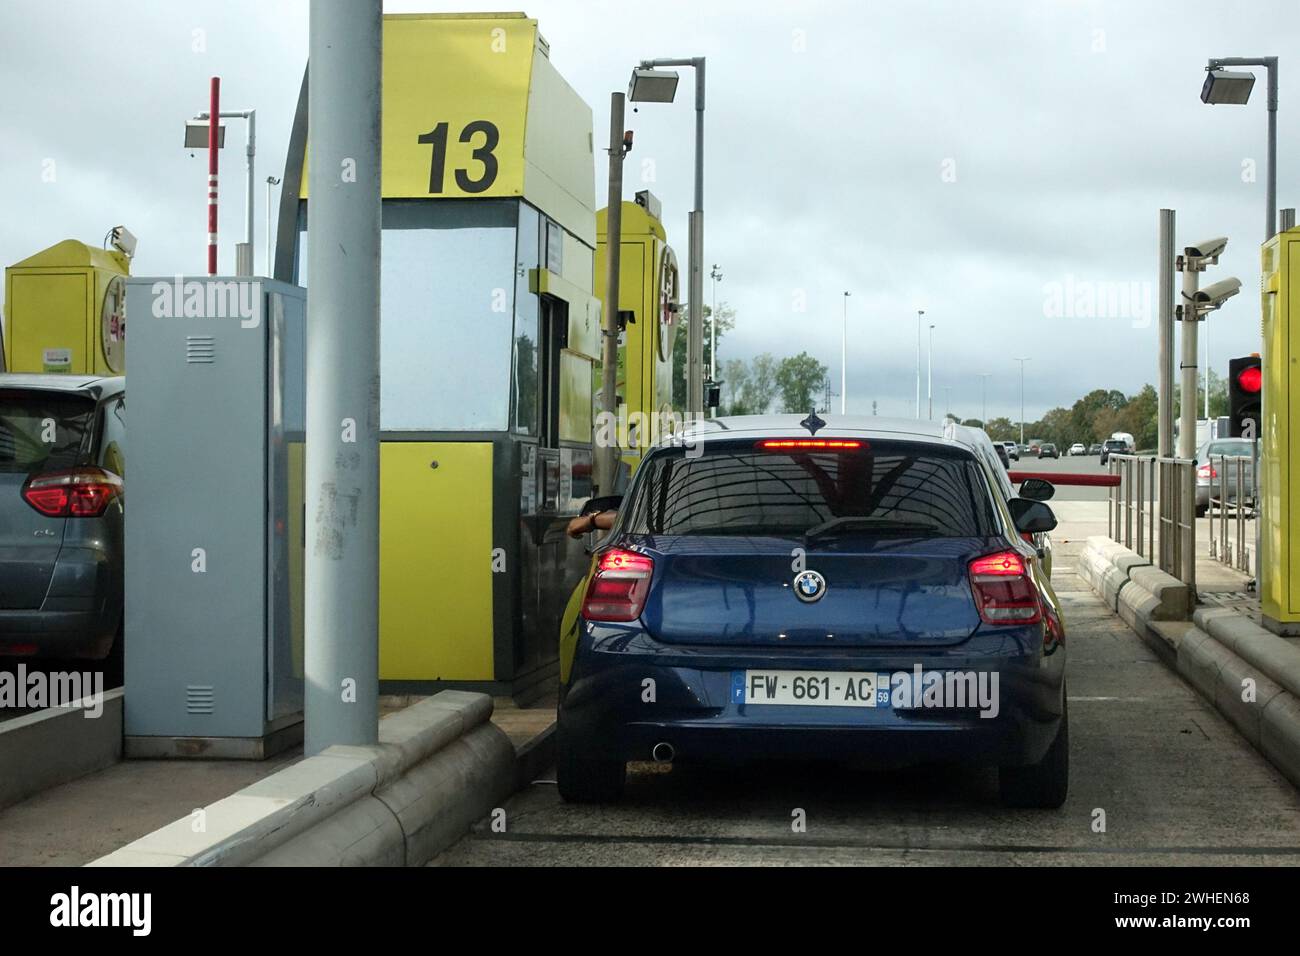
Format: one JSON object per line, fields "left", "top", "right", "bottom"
{"left": 623, "top": 441, "right": 996, "bottom": 537}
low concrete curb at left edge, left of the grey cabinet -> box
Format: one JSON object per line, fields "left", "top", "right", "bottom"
{"left": 0, "top": 687, "right": 122, "bottom": 808}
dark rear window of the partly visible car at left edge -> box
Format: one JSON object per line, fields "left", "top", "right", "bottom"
{"left": 0, "top": 390, "right": 95, "bottom": 475}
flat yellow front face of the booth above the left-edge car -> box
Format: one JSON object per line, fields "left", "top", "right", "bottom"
{"left": 5, "top": 272, "right": 95, "bottom": 375}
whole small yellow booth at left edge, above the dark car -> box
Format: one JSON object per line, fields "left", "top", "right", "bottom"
{"left": 0, "top": 239, "right": 130, "bottom": 375}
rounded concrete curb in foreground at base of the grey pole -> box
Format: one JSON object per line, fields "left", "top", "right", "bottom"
{"left": 90, "top": 691, "right": 516, "bottom": 866}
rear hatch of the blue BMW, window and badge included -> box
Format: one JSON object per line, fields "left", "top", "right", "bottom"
{"left": 624, "top": 441, "right": 1008, "bottom": 648}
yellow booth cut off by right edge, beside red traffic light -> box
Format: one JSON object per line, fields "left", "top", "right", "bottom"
{"left": 1256, "top": 229, "right": 1300, "bottom": 633}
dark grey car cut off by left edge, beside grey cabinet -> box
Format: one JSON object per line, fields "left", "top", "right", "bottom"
{"left": 0, "top": 373, "right": 126, "bottom": 659}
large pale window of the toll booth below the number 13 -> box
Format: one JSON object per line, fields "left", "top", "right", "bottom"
{"left": 298, "top": 199, "right": 519, "bottom": 432}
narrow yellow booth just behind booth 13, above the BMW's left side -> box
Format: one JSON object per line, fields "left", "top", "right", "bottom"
{"left": 595, "top": 191, "right": 685, "bottom": 468}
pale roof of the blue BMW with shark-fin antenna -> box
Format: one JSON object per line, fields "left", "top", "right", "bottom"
{"left": 658, "top": 415, "right": 992, "bottom": 450}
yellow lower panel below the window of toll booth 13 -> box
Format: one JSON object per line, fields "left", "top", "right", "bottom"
{"left": 380, "top": 441, "right": 494, "bottom": 680}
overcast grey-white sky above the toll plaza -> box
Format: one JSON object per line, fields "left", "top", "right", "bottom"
{"left": 0, "top": 0, "right": 1300, "bottom": 420}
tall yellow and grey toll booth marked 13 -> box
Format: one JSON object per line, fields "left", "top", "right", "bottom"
{"left": 276, "top": 7, "right": 601, "bottom": 700}
